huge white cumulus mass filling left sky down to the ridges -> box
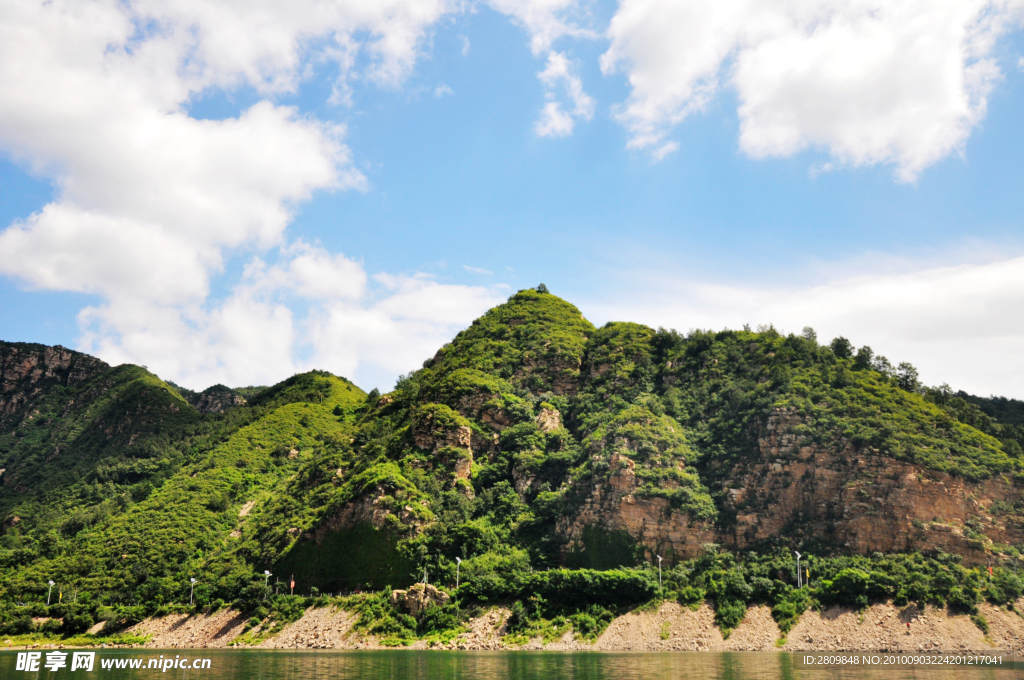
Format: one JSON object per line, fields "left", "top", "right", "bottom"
{"left": 0, "top": 0, "right": 496, "bottom": 388}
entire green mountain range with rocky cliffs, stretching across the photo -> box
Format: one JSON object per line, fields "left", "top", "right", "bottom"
{"left": 0, "top": 289, "right": 1024, "bottom": 639}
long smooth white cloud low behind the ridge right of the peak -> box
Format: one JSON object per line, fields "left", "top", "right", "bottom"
{"left": 581, "top": 257, "right": 1024, "bottom": 398}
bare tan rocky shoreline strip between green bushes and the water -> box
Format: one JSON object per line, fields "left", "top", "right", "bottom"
{"left": 105, "top": 599, "right": 1024, "bottom": 653}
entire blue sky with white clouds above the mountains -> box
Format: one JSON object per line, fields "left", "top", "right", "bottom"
{"left": 0, "top": 0, "right": 1024, "bottom": 397}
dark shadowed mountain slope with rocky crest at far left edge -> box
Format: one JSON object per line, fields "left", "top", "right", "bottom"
{"left": 0, "top": 343, "right": 200, "bottom": 533}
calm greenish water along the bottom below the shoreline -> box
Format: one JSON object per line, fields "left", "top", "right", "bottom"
{"left": 0, "top": 649, "right": 1024, "bottom": 680}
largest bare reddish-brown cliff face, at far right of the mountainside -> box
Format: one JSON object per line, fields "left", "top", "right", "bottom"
{"left": 722, "top": 410, "right": 1024, "bottom": 563}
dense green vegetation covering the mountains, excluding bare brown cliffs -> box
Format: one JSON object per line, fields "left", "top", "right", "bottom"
{"left": 0, "top": 290, "right": 1024, "bottom": 644}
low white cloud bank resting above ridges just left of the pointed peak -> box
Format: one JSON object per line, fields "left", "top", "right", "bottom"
{"left": 80, "top": 242, "right": 504, "bottom": 389}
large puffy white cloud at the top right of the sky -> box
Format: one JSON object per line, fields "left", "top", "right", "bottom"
{"left": 601, "top": 0, "right": 1022, "bottom": 181}
